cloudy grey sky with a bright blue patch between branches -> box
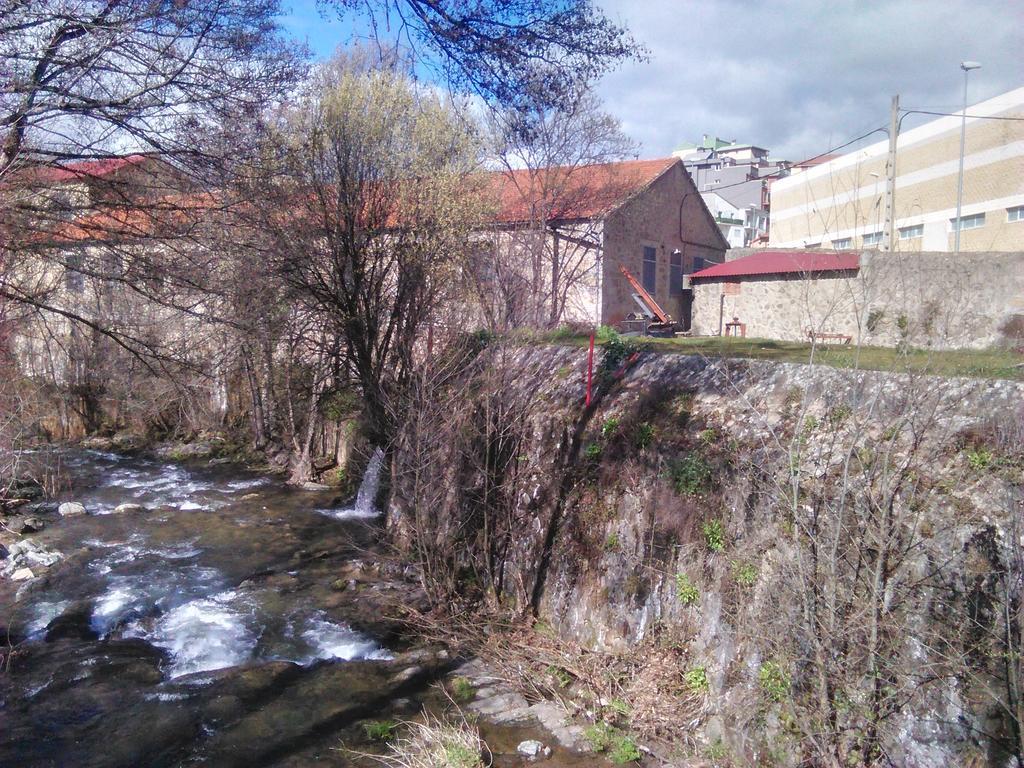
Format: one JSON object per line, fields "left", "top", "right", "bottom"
{"left": 282, "top": 0, "right": 1024, "bottom": 161}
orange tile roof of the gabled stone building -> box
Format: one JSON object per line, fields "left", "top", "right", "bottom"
{"left": 486, "top": 158, "right": 682, "bottom": 224}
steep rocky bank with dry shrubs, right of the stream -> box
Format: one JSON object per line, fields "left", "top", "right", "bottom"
{"left": 390, "top": 347, "right": 1024, "bottom": 766}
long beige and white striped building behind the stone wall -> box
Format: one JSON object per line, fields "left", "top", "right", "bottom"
{"left": 770, "top": 88, "right": 1024, "bottom": 252}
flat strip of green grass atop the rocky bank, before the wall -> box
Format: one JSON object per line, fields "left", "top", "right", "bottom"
{"left": 536, "top": 333, "right": 1024, "bottom": 381}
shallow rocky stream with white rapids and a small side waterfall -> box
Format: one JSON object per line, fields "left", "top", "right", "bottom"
{"left": 0, "top": 450, "right": 593, "bottom": 768}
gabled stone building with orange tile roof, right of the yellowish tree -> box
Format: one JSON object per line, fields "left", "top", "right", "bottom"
{"left": 477, "top": 158, "right": 729, "bottom": 326}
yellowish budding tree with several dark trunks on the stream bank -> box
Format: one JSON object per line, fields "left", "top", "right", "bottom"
{"left": 249, "top": 49, "right": 485, "bottom": 473}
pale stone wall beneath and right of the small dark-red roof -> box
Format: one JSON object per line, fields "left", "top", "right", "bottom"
{"left": 693, "top": 251, "right": 1024, "bottom": 349}
